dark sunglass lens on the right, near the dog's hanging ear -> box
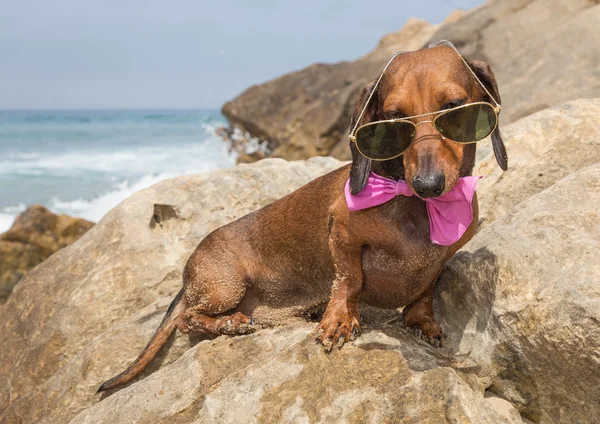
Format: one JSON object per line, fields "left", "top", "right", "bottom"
{"left": 435, "top": 104, "right": 497, "bottom": 143}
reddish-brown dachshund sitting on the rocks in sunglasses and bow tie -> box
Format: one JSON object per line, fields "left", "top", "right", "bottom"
{"left": 99, "top": 46, "right": 506, "bottom": 391}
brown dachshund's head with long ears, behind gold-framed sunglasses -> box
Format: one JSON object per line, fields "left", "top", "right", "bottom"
{"left": 350, "top": 46, "right": 508, "bottom": 197}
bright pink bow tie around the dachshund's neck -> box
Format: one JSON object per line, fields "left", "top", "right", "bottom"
{"left": 344, "top": 172, "right": 481, "bottom": 246}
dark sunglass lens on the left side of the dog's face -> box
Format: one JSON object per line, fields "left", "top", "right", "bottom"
{"left": 356, "top": 122, "right": 415, "bottom": 160}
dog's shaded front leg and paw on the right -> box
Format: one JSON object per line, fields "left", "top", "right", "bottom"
{"left": 402, "top": 278, "right": 444, "bottom": 347}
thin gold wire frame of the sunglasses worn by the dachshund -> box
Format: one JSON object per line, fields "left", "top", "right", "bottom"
{"left": 349, "top": 40, "right": 502, "bottom": 162}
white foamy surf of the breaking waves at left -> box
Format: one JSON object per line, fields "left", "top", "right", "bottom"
{"left": 0, "top": 128, "right": 236, "bottom": 233}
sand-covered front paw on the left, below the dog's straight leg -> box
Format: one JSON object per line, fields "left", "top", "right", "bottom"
{"left": 317, "top": 308, "right": 360, "bottom": 352}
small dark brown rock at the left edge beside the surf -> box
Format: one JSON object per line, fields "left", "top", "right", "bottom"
{"left": 0, "top": 205, "right": 94, "bottom": 302}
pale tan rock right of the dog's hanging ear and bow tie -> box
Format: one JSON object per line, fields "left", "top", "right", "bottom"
{"left": 473, "top": 99, "right": 600, "bottom": 223}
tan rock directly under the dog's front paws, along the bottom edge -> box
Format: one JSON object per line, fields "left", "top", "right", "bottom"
{"left": 71, "top": 324, "right": 521, "bottom": 424}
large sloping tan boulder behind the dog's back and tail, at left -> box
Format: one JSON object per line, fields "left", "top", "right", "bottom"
{"left": 0, "top": 158, "right": 341, "bottom": 423}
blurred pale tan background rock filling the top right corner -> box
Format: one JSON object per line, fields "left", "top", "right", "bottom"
{"left": 432, "top": 0, "right": 600, "bottom": 123}
